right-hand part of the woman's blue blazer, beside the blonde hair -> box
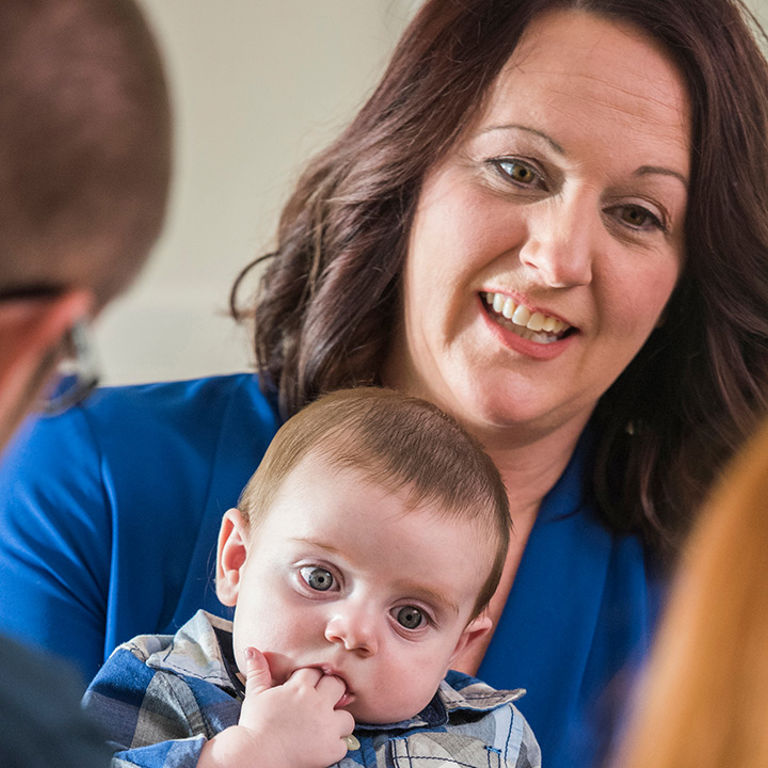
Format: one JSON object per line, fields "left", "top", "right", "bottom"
{"left": 478, "top": 436, "right": 660, "bottom": 768}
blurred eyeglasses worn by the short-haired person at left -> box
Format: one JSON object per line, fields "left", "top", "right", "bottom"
{"left": 0, "top": 285, "right": 99, "bottom": 416}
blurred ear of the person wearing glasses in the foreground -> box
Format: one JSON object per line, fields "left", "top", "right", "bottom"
{"left": 0, "top": 290, "right": 93, "bottom": 448}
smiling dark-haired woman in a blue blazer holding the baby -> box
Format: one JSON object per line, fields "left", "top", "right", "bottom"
{"left": 0, "top": 0, "right": 768, "bottom": 766}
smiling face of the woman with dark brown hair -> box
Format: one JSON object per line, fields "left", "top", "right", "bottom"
{"left": 385, "top": 10, "right": 690, "bottom": 444}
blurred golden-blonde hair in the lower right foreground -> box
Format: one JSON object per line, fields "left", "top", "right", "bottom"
{"left": 615, "top": 424, "right": 768, "bottom": 768}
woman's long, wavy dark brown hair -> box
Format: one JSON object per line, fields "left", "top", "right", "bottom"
{"left": 232, "top": 0, "right": 768, "bottom": 550}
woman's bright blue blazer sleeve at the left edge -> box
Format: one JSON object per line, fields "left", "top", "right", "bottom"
{"left": 0, "top": 409, "right": 112, "bottom": 680}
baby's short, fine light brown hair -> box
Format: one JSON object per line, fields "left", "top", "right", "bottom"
{"left": 238, "top": 387, "right": 511, "bottom": 617}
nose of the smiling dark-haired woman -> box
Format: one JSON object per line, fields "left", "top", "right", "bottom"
{"left": 519, "top": 195, "right": 603, "bottom": 288}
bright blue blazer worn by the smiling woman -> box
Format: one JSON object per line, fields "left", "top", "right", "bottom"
{"left": 0, "top": 374, "right": 658, "bottom": 768}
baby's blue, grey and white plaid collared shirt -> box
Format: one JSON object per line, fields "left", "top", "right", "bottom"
{"left": 83, "top": 611, "right": 541, "bottom": 768}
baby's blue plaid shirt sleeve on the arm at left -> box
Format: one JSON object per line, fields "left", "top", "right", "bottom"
{"left": 83, "top": 644, "right": 207, "bottom": 768}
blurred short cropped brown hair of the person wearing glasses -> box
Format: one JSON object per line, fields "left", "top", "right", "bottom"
{"left": 0, "top": 0, "right": 171, "bottom": 305}
